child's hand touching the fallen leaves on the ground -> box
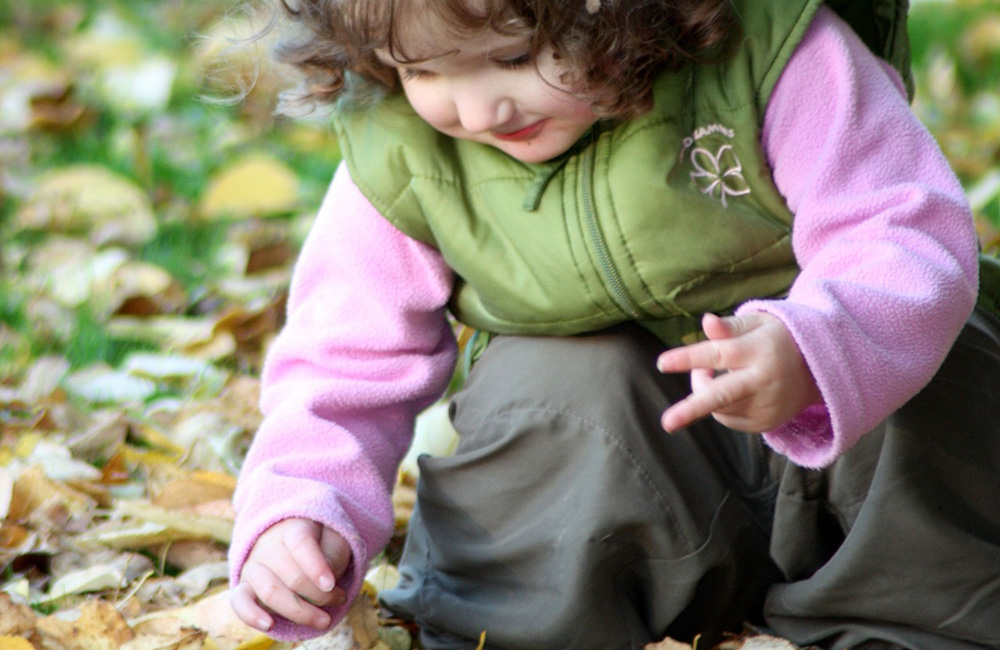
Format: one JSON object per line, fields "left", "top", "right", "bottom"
{"left": 229, "top": 519, "right": 351, "bottom": 632}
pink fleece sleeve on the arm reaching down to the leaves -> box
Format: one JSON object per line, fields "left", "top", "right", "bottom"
{"left": 230, "top": 165, "right": 455, "bottom": 640}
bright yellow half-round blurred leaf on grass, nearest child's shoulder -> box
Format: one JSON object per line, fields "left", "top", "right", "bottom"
{"left": 199, "top": 154, "right": 299, "bottom": 219}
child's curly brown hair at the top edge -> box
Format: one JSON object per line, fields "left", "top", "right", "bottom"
{"left": 276, "top": 0, "right": 736, "bottom": 118}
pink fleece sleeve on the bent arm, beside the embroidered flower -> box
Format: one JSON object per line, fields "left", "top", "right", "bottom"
{"left": 737, "top": 8, "right": 978, "bottom": 467}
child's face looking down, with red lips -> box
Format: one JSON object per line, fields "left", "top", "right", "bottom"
{"left": 380, "top": 21, "right": 597, "bottom": 162}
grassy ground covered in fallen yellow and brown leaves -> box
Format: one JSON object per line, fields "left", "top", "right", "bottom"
{"left": 0, "top": 0, "right": 1000, "bottom": 650}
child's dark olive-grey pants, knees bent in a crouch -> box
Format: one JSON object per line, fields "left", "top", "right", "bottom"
{"left": 383, "top": 315, "right": 1000, "bottom": 650}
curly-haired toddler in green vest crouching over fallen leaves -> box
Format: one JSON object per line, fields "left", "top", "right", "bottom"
{"left": 230, "top": 0, "right": 1000, "bottom": 650}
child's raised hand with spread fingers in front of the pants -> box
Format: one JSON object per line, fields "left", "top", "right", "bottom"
{"left": 657, "top": 312, "right": 822, "bottom": 433}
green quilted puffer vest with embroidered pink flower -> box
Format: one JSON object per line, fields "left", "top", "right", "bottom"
{"left": 335, "top": 0, "right": 905, "bottom": 345}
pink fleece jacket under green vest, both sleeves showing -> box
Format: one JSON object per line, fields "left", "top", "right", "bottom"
{"left": 230, "top": 9, "right": 978, "bottom": 639}
